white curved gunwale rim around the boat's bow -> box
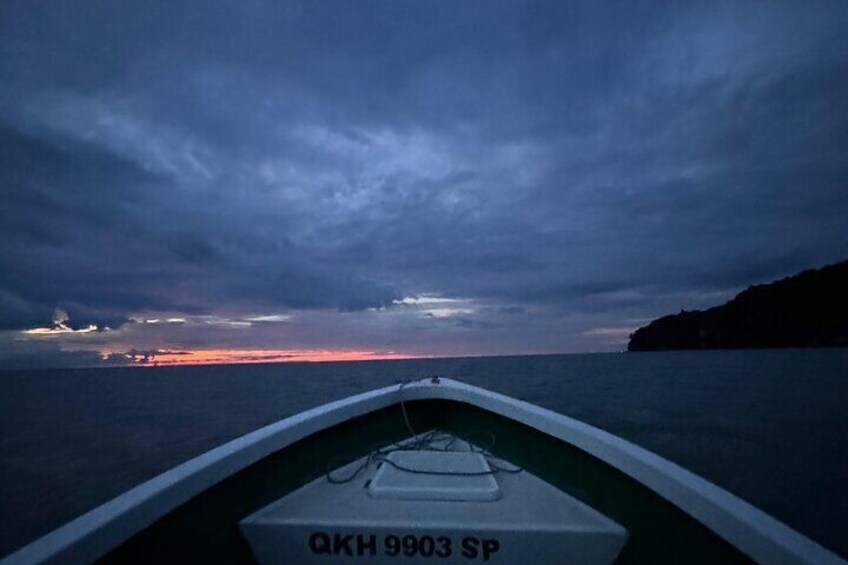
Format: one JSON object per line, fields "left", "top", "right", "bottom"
{"left": 0, "top": 378, "right": 845, "bottom": 565}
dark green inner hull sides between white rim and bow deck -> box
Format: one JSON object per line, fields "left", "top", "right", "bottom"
{"left": 101, "top": 400, "right": 752, "bottom": 563}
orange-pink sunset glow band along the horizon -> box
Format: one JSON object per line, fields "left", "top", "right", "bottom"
{"left": 117, "top": 349, "right": 421, "bottom": 367}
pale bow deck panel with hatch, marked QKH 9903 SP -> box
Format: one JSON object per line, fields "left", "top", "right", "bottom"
{"left": 241, "top": 432, "right": 627, "bottom": 565}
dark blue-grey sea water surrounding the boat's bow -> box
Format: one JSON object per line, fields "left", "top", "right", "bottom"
{"left": 0, "top": 349, "right": 848, "bottom": 556}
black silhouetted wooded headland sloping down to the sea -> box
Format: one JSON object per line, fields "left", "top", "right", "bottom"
{"left": 627, "top": 261, "right": 848, "bottom": 351}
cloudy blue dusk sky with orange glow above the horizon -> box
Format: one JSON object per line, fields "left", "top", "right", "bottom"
{"left": 0, "top": 0, "right": 848, "bottom": 368}
